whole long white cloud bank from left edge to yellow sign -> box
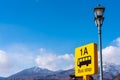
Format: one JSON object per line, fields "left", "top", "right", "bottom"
{"left": 0, "top": 44, "right": 74, "bottom": 77}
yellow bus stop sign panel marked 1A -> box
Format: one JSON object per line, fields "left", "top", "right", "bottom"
{"left": 75, "top": 43, "right": 98, "bottom": 77}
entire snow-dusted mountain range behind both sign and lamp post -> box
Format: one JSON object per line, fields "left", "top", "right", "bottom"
{"left": 0, "top": 63, "right": 120, "bottom": 80}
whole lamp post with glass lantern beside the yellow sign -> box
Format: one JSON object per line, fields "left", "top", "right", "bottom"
{"left": 94, "top": 4, "right": 105, "bottom": 80}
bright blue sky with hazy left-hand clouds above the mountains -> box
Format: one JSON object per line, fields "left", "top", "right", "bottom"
{"left": 0, "top": 0, "right": 120, "bottom": 76}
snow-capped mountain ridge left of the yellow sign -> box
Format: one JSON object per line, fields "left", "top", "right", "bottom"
{"left": 8, "top": 67, "right": 74, "bottom": 80}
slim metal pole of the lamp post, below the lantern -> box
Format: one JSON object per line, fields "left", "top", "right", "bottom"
{"left": 98, "top": 26, "right": 103, "bottom": 80}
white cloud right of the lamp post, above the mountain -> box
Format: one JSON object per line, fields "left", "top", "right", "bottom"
{"left": 103, "top": 38, "right": 120, "bottom": 65}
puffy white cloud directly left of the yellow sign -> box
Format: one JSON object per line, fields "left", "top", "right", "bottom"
{"left": 35, "top": 48, "right": 74, "bottom": 71}
